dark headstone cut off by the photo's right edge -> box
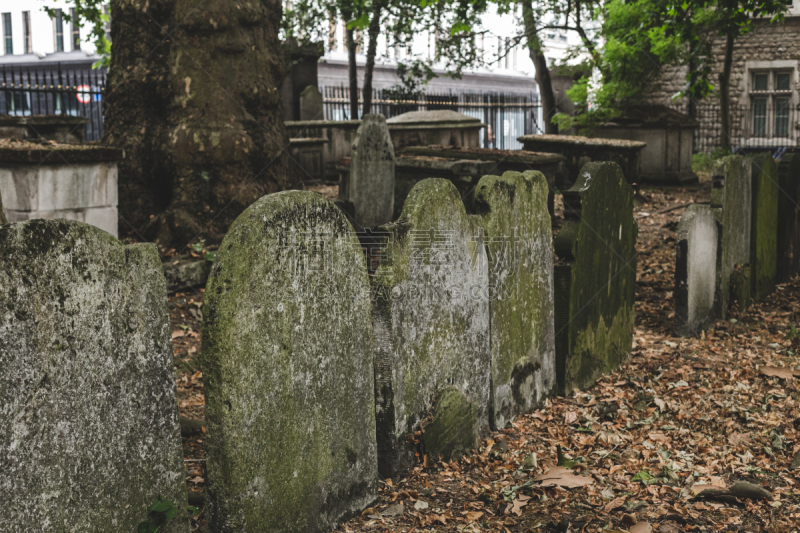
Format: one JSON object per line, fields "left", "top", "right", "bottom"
{"left": 776, "top": 153, "right": 800, "bottom": 283}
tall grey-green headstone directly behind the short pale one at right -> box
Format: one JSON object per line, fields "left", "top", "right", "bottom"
{"left": 711, "top": 155, "right": 752, "bottom": 319}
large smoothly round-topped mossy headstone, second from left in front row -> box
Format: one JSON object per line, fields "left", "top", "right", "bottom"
{"left": 201, "top": 191, "right": 377, "bottom": 533}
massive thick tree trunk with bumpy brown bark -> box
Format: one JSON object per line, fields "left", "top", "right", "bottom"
{"left": 105, "top": 0, "right": 296, "bottom": 247}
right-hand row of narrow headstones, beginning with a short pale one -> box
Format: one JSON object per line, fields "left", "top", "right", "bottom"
{"left": 675, "top": 153, "right": 800, "bottom": 335}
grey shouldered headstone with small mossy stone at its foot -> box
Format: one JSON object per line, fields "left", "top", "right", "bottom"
{"left": 373, "top": 178, "right": 491, "bottom": 477}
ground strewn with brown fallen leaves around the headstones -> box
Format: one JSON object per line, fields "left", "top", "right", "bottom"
{"left": 169, "top": 181, "right": 800, "bottom": 533}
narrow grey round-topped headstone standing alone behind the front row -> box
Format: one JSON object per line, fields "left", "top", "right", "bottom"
{"left": 340, "top": 114, "right": 395, "bottom": 229}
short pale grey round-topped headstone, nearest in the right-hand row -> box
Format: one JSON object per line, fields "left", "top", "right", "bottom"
{"left": 675, "top": 205, "right": 718, "bottom": 335}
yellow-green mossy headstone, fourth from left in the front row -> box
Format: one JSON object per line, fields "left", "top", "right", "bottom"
{"left": 473, "top": 171, "right": 555, "bottom": 429}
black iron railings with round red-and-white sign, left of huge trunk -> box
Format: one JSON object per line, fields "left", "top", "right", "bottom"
{"left": 0, "top": 63, "right": 106, "bottom": 141}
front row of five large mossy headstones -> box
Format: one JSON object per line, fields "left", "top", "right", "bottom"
{"left": 0, "top": 163, "right": 636, "bottom": 532}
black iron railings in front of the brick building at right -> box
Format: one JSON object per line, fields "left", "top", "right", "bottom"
{"left": 681, "top": 103, "right": 800, "bottom": 153}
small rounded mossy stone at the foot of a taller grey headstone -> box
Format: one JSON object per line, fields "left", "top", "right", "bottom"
{"left": 422, "top": 388, "right": 478, "bottom": 461}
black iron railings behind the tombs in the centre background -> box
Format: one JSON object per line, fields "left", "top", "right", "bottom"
{"left": 322, "top": 86, "right": 542, "bottom": 150}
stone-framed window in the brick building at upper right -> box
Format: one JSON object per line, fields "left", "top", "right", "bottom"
{"left": 750, "top": 70, "right": 793, "bottom": 137}
